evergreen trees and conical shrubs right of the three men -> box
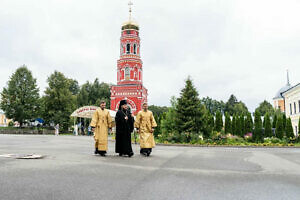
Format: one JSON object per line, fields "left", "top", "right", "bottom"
{"left": 152, "top": 77, "right": 300, "bottom": 143}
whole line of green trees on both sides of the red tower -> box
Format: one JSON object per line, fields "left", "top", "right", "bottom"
{"left": 0, "top": 65, "right": 300, "bottom": 143}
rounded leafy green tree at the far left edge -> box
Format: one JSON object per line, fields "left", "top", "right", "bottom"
{"left": 0, "top": 65, "right": 40, "bottom": 127}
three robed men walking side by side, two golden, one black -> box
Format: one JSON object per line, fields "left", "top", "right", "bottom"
{"left": 90, "top": 100, "right": 157, "bottom": 157}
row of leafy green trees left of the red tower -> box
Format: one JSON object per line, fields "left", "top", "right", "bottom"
{"left": 0, "top": 65, "right": 110, "bottom": 130}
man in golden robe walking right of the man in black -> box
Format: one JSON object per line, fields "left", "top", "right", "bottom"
{"left": 134, "top": 103, "right": 157, "bottom": 156}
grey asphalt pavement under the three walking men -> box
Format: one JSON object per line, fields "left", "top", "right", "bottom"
{"left": 0, "top": 135, "right": 300, "bottom": 200}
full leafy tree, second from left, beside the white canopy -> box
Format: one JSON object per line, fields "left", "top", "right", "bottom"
{"left": 43, "top": 71, "right": 76, "bottom": 130}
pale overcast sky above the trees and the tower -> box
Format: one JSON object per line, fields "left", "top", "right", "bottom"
{"left": 0, "top": 0, "right": 300, "bottom": 111}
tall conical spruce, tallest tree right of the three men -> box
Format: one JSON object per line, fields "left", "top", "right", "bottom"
{"left": 175, "top": 77, "right": 206, "bottom": 142}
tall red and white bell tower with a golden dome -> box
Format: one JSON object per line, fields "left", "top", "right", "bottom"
{"left": 110, "top": 2, "right": 148, "bottom": 115}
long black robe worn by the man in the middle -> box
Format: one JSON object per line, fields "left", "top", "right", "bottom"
{"left": 115, "top": 110, "right": 134, "bottom": 156}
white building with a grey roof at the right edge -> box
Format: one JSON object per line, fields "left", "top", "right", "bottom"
{"left": 282, "top": 83, "right": 300, "bottom": 135}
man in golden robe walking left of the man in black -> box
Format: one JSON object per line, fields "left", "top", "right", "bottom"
{"left": 90, "top": 101, "right": 112, "bottom": 156}
